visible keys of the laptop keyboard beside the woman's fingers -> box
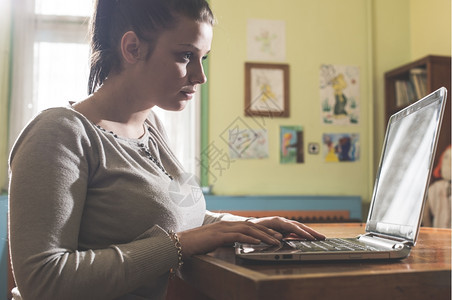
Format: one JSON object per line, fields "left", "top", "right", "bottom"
{"left": 286, "top": 238, "right": 378, "bottom": 252}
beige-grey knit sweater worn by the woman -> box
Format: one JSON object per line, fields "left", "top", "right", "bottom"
{"left": 9, "top": 107, "right": 242, "bottom": 300}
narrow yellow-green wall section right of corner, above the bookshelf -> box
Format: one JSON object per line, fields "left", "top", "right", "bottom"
{"left": 372, "top": 0, "right": 451, "bottom": 173}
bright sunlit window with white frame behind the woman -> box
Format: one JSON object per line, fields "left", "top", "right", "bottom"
{"left": 10, "top": 0, "right": 200, "bottom": 176}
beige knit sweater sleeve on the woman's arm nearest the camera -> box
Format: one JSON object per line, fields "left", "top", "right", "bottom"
{"left": 9, "top": 111, "right": 178, "bottom": 299}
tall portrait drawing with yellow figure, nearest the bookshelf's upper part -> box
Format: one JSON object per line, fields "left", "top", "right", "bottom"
{"left": 320, "top": 65, "right": 360, "bottom": 125}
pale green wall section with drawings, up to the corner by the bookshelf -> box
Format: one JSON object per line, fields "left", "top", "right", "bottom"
{"left": 209, "top": 0, "right": 373, "bottom": 198}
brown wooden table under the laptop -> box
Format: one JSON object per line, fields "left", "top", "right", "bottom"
{"left": 168, "top": 223, "right": 451, "bottom": 300}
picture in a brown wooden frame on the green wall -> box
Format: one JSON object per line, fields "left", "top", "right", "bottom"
{"left": 245, "top": 63, "right": 290, "bottom": 118}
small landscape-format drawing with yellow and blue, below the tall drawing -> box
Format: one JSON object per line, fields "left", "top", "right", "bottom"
{"left": 323, "top": 133, "right": 360, "bottom": 162}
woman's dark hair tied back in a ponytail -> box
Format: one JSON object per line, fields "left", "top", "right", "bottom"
{"left": 88, "top": 0, "right": 215, "bottom": 94}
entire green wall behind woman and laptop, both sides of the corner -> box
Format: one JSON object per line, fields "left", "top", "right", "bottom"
{"left": 205, "top": 0, "right": 450, "bottom": 202}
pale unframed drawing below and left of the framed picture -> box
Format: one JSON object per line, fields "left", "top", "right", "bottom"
{"left": 229, "top": 128, "right": 268, "bottom": 159}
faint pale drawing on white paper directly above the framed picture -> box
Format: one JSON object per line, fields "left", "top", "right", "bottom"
{"left": 247, "top": 19, "right": 286, "bottom": 61}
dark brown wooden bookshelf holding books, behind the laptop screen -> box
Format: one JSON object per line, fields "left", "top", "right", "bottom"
{"left": 385, "top": 55, "right": 452, "bottom": 179}
